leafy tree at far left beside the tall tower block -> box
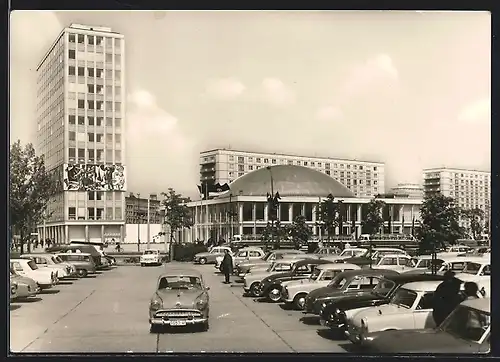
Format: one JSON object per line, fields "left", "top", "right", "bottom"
{"left": 9, "top": 140, "right": 62, "bottom": 253}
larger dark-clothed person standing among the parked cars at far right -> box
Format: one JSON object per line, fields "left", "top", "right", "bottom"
{"left": 432, "top": 270, "right": 463, "bottom": 326}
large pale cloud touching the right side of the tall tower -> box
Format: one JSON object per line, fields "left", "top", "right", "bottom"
{"left": 126, "top": 90, "right": 198, "bottom": 193}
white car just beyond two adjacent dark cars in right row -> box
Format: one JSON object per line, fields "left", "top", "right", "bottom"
{"left": 281, "top": 263, "right": 361, "bottom": 310}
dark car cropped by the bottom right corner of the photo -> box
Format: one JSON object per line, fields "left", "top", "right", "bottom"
{"left": 363, "top": 298, "right": 491, "bottom": 354}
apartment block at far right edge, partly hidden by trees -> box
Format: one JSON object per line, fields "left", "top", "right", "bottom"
{"left": 423, "top": 167, "right": 491, "bottom": 227}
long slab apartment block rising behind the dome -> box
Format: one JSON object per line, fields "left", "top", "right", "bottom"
{"left": 200, "top": 148, "right": 385, "bottom": 197}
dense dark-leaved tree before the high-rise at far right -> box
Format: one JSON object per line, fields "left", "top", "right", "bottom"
{"left": 418, "top": 194, "right": 464, "bottom": 252}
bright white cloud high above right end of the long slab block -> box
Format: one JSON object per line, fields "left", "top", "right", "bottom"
{"left": 342, "top": 54, "right": 399, "bottom": 97}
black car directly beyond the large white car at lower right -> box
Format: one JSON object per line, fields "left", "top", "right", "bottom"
{"left": 319, "top": 274, "right": 444, "bottom": 334}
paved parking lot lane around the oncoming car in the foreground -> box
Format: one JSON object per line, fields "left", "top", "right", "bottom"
{"left": 10, "top": 263, "right": 350, "bottom": 353}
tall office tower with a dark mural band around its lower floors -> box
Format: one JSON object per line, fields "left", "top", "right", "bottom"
{"left": 37, "top": 24, "right": 126, "bottom": 243}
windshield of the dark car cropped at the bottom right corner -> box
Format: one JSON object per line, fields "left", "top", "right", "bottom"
{"left": 439, "top": 305, "right": 491, "bottom": 342}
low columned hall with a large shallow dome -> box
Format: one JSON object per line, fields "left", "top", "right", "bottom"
{"left": 180, "top": 165, "right": 422, "bottom": 242}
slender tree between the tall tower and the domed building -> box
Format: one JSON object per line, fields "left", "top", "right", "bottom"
{"left": 162, "top": 188, "right": 193, "bottom": 260}
